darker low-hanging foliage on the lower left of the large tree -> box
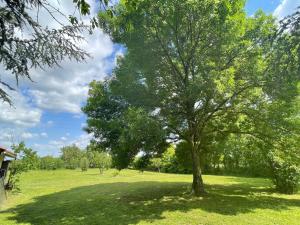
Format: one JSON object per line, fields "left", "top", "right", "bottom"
{"left": 83, "top": 81, "right": 166, "bottom": 169}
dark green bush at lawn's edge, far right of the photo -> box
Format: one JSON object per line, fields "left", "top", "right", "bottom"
{"left": 273, "top": 159, "right": 300, "bottom": 194}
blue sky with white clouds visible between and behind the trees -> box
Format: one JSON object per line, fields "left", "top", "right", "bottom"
{"left": 0, "top": 0, "right": 300, "bottom": 156}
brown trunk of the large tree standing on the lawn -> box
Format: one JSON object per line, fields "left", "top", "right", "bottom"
{"left": 192, "top": 146, "right": 205, "bottom": 196}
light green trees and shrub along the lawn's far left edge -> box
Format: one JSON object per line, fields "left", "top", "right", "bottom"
{"left": 6, "top": 142, "right": 111, "bottom": 190}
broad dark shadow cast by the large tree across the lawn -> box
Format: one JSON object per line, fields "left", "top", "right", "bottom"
{"left": 2, "top": 181, "right": 300, "bottom": 225}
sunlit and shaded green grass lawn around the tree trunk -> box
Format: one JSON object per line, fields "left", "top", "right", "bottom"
{"left": 0, "top": 169, "right": 300, "bottom": 225}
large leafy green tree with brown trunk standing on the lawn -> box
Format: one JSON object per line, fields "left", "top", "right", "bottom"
{"left": 84, "top": 0, "right": 298, "bottom": 195}
